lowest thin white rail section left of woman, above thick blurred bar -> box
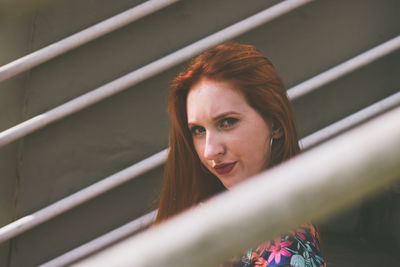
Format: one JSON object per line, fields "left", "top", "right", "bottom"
{"left": 39, "top": 210, "right": 157, "bottom": 267}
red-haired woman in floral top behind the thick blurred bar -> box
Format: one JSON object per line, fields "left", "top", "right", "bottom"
{"left": 156, "top": 42, "right": 324, "bottom": 267}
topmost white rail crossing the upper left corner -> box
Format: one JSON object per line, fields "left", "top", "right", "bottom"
{"left": 0, "top": 0, "right": 179, "bottom": 82}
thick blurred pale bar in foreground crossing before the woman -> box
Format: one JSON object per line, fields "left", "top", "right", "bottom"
{"left": 74, "top": 107, "right": 400, "bottom": 267}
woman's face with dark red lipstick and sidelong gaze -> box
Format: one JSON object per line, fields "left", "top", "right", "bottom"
{"left": 186, "top": 78, "right": 271, "bottom": 189}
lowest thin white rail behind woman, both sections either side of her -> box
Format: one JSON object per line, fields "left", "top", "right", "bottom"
{"left": 34, "top": 92, "right": 400, "bottom": 267}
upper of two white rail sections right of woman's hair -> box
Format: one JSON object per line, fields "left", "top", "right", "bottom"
{"left": 288, "top": 36, "right": 400, "bottom": 100}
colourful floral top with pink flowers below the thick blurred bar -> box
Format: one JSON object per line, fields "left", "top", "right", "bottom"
{"left": 219, "top": 224, "right": 326, "bottom": 267}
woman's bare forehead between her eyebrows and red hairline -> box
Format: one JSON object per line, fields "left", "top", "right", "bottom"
{"left": 186, "top": 79, "right": 251, "bottom": 123}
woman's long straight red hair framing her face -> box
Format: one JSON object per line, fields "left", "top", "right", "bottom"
{"left": 156, "top": 42, "right": 300, "bottom": 223}
